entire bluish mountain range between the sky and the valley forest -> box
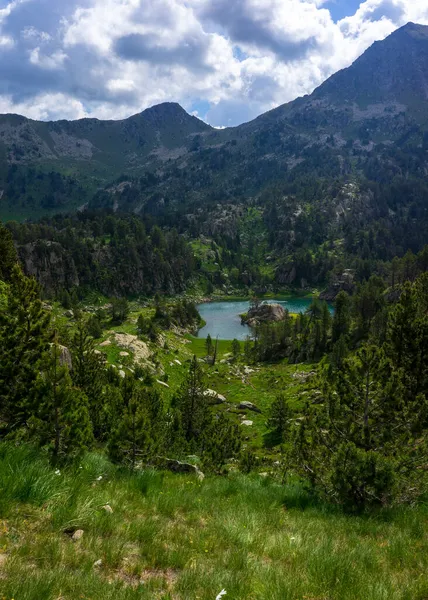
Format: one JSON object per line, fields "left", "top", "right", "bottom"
{"left": 0, "top": 23, "right": 428, "bottom": 248}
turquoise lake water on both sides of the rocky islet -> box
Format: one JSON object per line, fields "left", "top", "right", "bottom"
{"left": 198, "top": 298, "right": 332, "bottom": 340}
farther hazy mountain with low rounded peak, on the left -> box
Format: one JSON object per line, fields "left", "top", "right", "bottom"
{"left": 0, "top": 103, "right": 212, "bottom": 216}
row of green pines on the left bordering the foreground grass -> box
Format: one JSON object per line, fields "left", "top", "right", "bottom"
{"left": 0, "top": 231, "right": 241, "bottom": 472}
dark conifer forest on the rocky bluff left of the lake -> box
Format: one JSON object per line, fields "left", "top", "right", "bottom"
{"left": 7, "top": 211, "right": 198, "bottom": 297}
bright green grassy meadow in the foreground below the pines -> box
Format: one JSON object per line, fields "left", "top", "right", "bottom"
{"left": 0, "top": 444, "right": 428, "bottom": 600}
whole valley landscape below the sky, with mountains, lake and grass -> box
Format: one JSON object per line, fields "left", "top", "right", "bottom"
{"left": 0, "top": 23, "right": 428, "bottom": 600}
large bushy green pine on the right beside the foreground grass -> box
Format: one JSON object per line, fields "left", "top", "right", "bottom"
{"left": 293, "top": 345, "right": 428, "bottom": 509}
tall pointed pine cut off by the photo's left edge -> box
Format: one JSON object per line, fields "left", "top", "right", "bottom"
{"left": 0, "top": 265, "right": 50, "bottom": 431}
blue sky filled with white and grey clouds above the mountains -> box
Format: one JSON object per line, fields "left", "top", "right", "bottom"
{"left": 0, "top": 0, "right": 428, "bottom": 127}
